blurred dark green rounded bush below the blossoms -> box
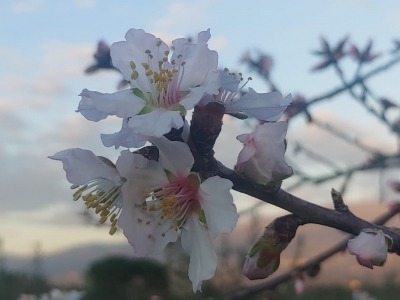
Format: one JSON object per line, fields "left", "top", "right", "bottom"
{"left": 84, "top": 257, "right": 168, "bottom": 300}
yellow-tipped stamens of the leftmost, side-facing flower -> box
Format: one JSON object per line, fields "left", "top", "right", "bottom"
{"left": 71, "top": 178, "right": 122, "bottom": 235}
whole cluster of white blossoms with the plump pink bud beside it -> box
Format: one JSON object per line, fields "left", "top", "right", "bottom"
{"left": 50, "top": 29, "right": 292, "bottom": 291}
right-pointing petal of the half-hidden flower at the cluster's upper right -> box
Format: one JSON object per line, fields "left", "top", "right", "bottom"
{"left": 225, "top": 88, "right": 292, "bottom": 121}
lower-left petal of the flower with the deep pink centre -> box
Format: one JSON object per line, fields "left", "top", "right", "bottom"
{"left": 118, "top": 195, "right": 157, "bottom": 257}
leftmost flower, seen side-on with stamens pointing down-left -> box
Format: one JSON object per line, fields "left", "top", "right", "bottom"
{"left": 49, "top": 148, "right": 126, "bottom": 235}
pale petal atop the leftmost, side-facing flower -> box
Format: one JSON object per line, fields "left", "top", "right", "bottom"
{"left": 49, "top": 148, "right": 121, "bottom": 185}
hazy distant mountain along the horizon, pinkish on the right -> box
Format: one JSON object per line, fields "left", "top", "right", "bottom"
{"left": 6, "top": 203, "right": 400, "bottom": 284}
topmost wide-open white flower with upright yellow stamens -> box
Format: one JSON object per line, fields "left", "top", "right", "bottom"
{"left": 78, "top": 29, "right": 219, "bottom": 137}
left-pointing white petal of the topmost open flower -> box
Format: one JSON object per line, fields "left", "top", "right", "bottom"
{"left": 85, "top": 90, "right": 146, "bottom": 118}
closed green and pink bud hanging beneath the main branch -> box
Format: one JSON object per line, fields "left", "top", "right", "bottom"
{"left": 243, "top": 215, "right": 300, "bottom": 280}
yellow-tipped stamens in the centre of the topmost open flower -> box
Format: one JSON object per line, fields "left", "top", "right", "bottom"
{"left": 130, "top": 41, "right": 186, "bottom": 108}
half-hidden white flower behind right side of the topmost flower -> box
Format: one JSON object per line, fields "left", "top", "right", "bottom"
{"left": 201, "top": 69, "right": 292, "bottom": 122}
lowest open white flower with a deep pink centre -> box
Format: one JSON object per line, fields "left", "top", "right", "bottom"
{"left": 118, "top": 137, "right": 238, "bottom": 291}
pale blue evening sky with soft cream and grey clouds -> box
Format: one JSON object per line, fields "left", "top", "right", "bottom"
{"left": 0, "top": 0, "right": 400, "bottom": 255}
